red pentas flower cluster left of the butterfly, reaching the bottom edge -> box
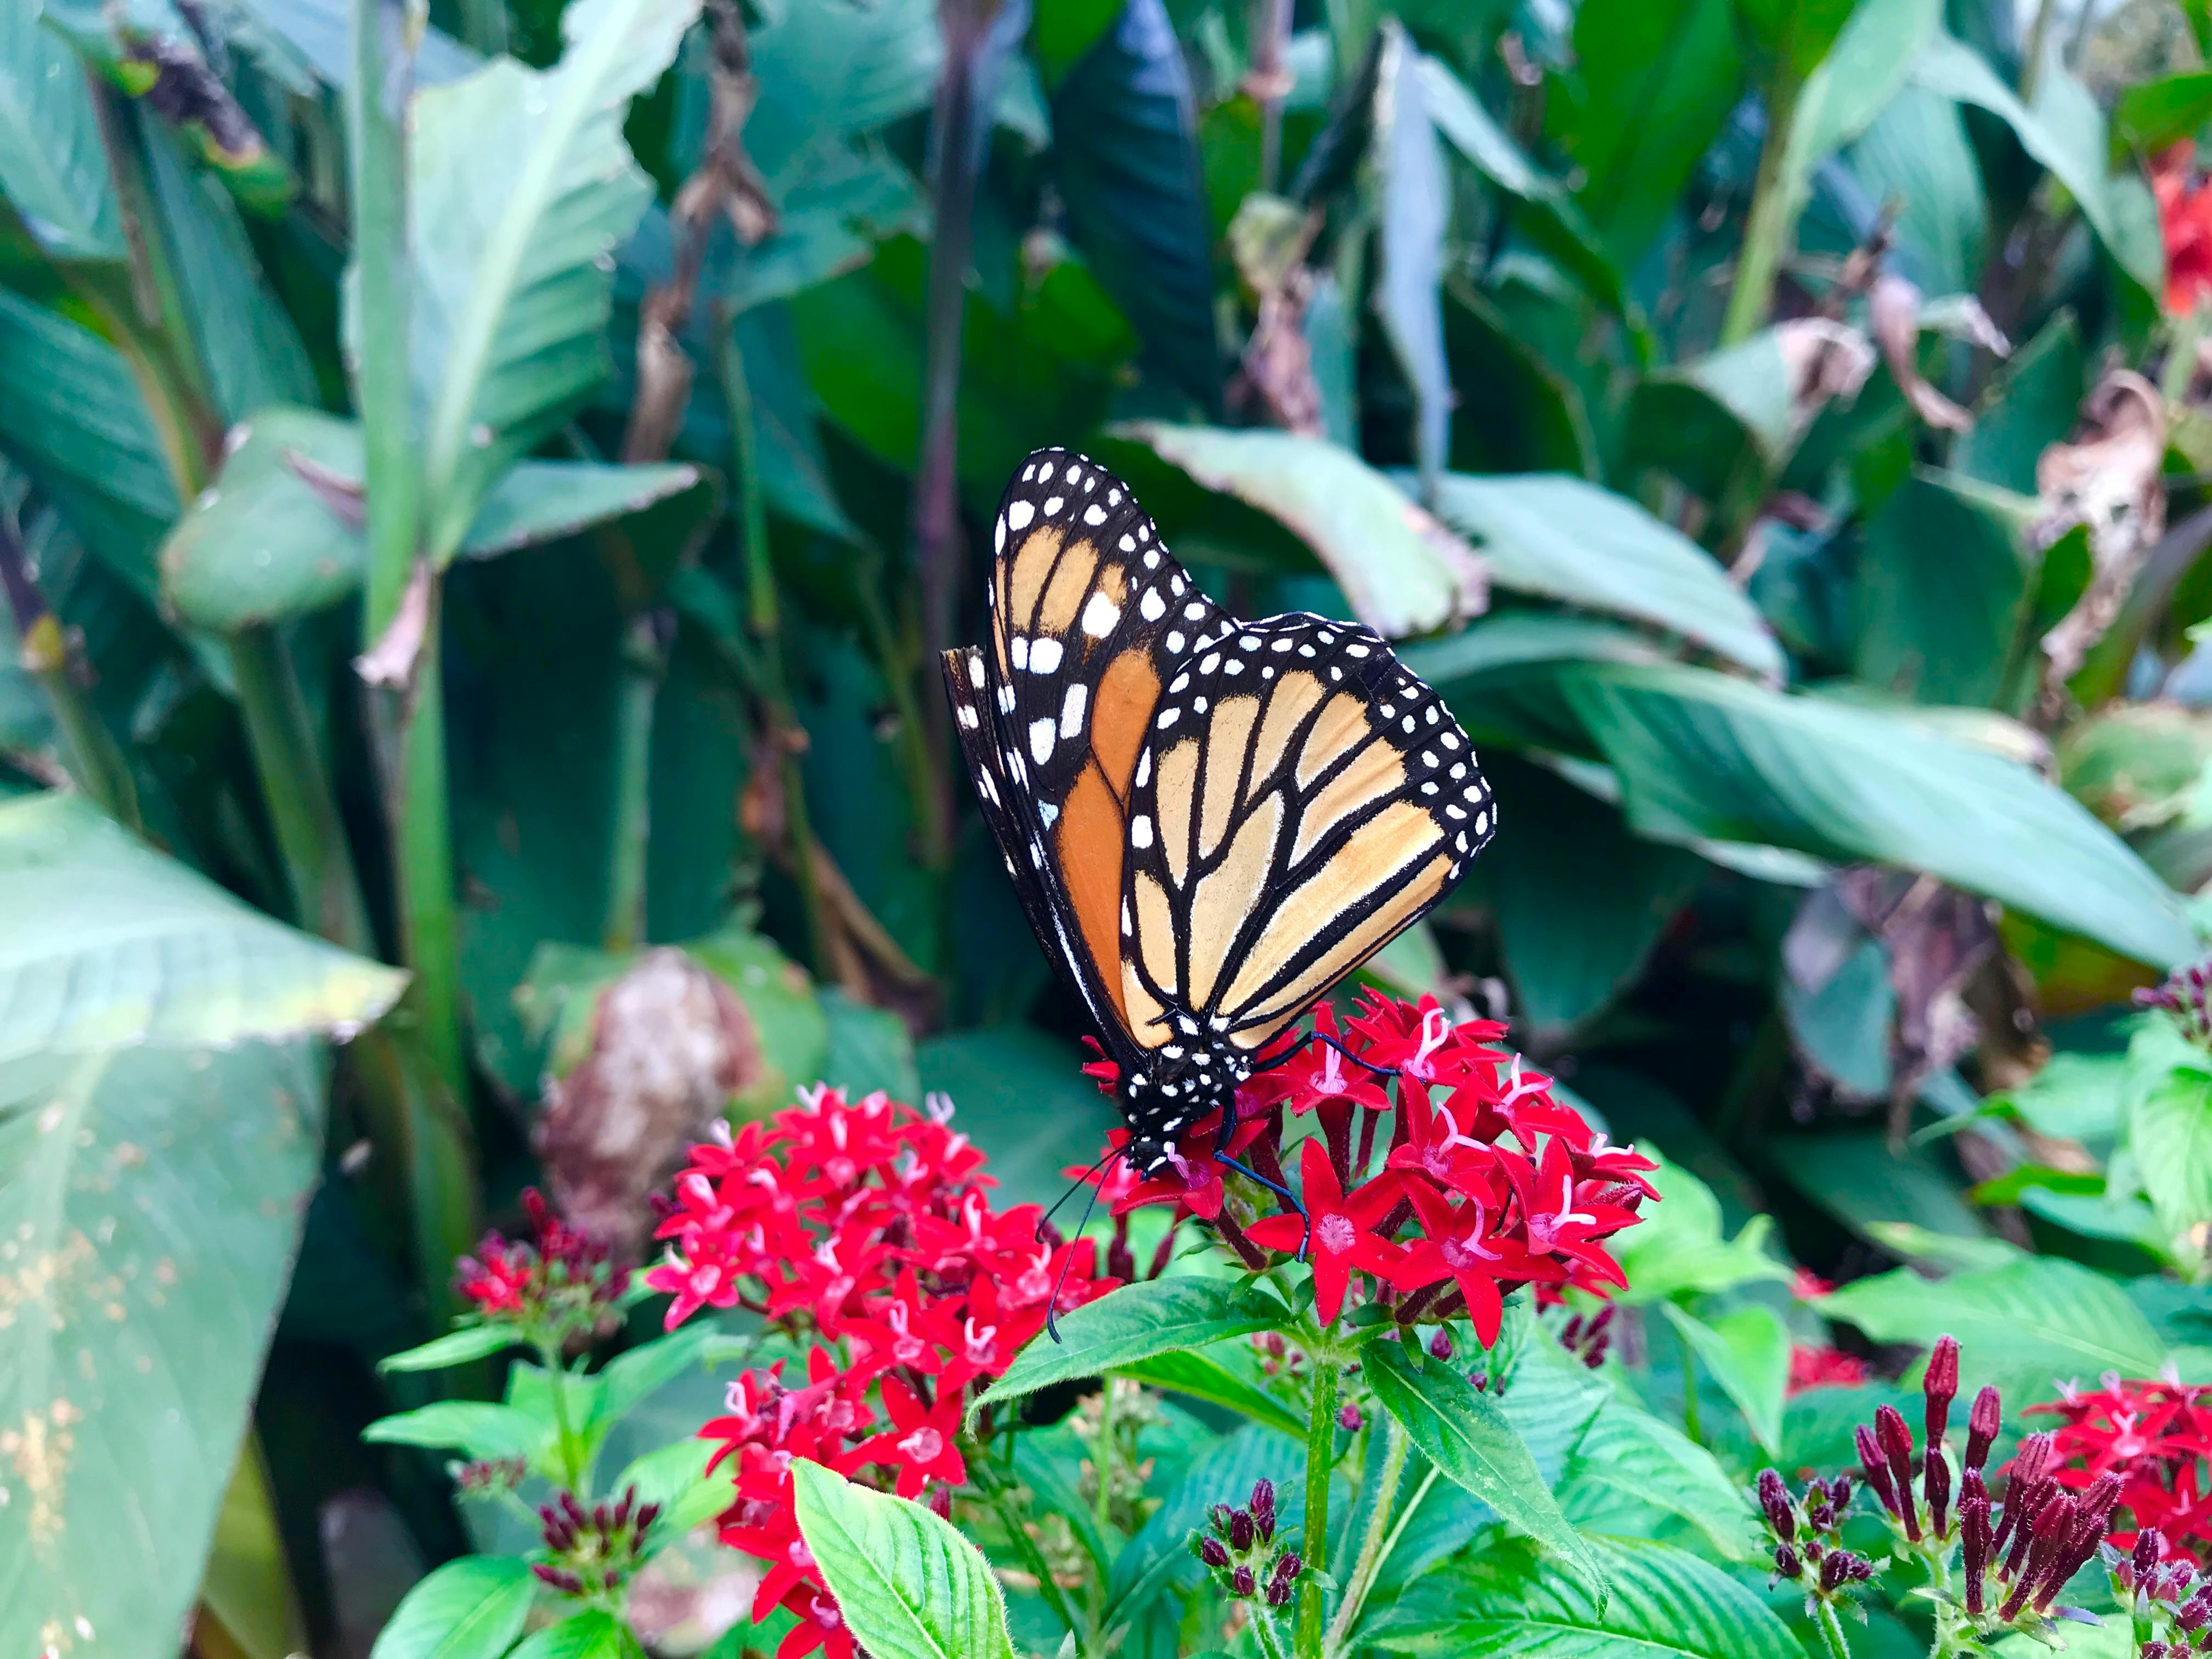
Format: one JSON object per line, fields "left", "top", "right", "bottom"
{"left": 646, "top": 1088, "right": 1117, "bottom": 1659}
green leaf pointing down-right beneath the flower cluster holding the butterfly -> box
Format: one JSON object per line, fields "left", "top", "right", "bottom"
{"left": 1363, "top": 1340, "right": 1606, "bottom": 1606}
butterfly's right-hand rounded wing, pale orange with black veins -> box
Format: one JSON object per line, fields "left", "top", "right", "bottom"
{"left": 1121, "top": 615, "right": 1498, "bottom": 1051}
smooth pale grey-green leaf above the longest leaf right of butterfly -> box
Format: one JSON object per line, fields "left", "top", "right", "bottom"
{"left": 1436, "top": 473, "right": 1783, "bottom": 675}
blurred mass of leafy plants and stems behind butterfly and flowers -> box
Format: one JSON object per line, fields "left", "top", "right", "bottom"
{"left": 0, "top": 0, "right": 2212, "bottom": 1659}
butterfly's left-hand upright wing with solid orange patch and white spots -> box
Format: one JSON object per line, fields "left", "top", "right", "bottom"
{"left": 945, "top": 449, "right": 1223, "bottom": 1064}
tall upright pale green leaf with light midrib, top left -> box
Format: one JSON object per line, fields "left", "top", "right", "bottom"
{"left": 409, "top": 0, "right": 699, "bottom": 560}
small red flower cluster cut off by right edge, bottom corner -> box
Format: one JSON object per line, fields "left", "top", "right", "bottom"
{"left": 2028, "top": 1372, "right": 2212, "bottom": 1560}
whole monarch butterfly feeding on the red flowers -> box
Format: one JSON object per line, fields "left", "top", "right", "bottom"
{"left": 943, "top": 449, "right": 1498, "bottom": 1175}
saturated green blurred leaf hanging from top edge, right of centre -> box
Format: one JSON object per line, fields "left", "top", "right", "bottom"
{"left": 1544, "top": 0, "right": 1743, "bottom": 268}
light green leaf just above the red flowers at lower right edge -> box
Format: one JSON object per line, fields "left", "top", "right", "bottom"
{"left": 1816, "top": 1256, "right": 2165, "bottom": 1404}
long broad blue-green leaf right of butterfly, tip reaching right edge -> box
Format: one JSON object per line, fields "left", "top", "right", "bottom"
{"left": 1564, "top": 664, "right": 2197, "bottom": 967}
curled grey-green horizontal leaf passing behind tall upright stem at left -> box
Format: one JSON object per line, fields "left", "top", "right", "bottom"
{"left": 161, "top": 405, "right": 714, "bottom": 633}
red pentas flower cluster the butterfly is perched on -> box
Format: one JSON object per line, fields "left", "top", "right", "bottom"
{"left": 1068, "top": 991, "right": 1657, "bottom": 1347}
